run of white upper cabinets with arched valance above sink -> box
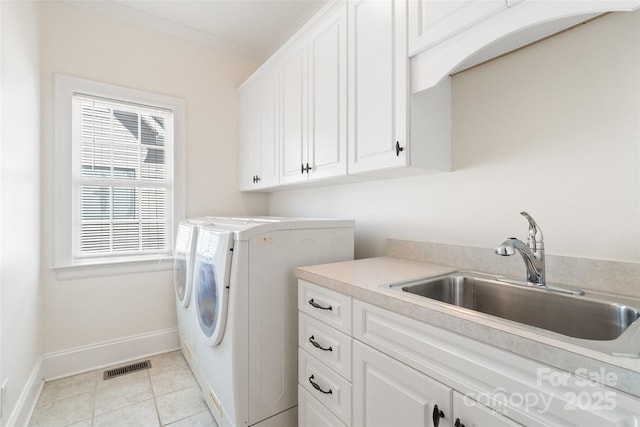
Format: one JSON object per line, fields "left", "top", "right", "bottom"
{"left": 238, "top": 0, "right": 640, "bottom": 191}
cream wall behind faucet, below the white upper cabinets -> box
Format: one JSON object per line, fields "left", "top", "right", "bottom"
{"left": 270, "top": 12, "right": 640, "bottom": 262}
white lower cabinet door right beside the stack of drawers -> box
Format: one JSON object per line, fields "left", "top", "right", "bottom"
{"left": 352, "top": 340, "right": 454, "bottom": 427}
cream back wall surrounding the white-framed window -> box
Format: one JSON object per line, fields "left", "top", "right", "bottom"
{"left": 41, "top": 2, "right": 268, "bottom": 353}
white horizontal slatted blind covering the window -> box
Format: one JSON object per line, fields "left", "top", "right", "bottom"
{"left": 72, "top": 93, "right": 173, "bottom": 261}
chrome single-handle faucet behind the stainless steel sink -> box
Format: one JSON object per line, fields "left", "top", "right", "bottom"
{"left": 496, "top": 212, "right": 546, "bottom": 287}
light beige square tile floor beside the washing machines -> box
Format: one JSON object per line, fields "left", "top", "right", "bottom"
{"left": 29, "top": 351, "right": 216, "bottom": 427}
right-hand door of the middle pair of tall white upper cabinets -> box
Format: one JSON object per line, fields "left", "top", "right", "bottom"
{"left": 305, "top": 5, "right": 347, "bottom": 179}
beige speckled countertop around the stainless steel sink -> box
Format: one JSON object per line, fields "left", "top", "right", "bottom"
{"left": 296, "top": 257, "right": 640, "bottom": 397}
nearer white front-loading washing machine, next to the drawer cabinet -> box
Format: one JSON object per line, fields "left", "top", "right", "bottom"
{"left": 194, "top": 217, "right": 354, "bottom": 427}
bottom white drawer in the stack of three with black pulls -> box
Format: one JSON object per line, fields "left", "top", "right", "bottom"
{"left": 298, "top": 349, "right": 351, "bottom": 425}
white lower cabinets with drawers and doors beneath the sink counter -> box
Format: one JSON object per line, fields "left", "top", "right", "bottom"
{"left": 298, "top": 280, "right": 640, "bottom": 427}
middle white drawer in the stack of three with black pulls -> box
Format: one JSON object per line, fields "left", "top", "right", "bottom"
{"left": 298, "top": 313, "right": 352, "bottom": 381}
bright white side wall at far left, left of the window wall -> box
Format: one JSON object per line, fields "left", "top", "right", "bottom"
{"left": 0, "top": 2, "right": 42, "bottom": 425}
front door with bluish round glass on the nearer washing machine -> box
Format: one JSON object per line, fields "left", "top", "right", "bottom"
{"left": 194, "top": 227, "right": 233, "bottom": 345}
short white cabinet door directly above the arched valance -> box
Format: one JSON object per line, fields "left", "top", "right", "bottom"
{"left": 408, "top": 0, "right": 507, "bottom": 56}
